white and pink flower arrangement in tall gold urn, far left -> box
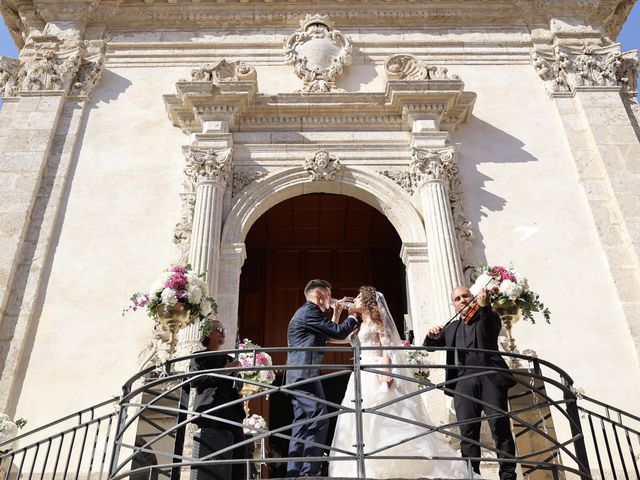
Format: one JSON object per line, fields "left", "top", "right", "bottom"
{"left": 122, "top": 265, "right": 218, "bottom": 320}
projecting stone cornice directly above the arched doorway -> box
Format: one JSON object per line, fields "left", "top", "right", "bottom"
{"left": 163, "top": 72, "right": 476, "bottom": 134}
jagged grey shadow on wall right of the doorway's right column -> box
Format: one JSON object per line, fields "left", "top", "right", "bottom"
{"left": 452, "top": 116, "right": 538, "bottom": 268}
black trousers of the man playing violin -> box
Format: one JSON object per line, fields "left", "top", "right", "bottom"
{"left": 454, "top": 376, "right": 516, "bottom": 480}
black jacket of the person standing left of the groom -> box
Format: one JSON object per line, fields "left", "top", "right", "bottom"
{"left": 189, "top": 354, "right": 244, "bottom": 428}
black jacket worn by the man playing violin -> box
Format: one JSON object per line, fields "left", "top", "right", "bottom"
{"left": 422, "top": 305, "right": 516, "bottom": 396}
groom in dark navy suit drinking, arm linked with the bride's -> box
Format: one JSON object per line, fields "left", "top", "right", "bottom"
{"left": 287, "top": 279, "right": 358, "bottom": 478}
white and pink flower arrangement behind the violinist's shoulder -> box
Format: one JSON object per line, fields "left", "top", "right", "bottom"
{"left": 471, "top": 265, "right": 551, "bottom": 323}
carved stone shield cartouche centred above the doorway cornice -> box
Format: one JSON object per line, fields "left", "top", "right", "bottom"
{"left": 283, "top": 14, "right": 352, "bottom": 92}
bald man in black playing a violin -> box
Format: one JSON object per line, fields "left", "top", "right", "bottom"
{"left": 423, "top": 287, "right": 516, "bottom": 480}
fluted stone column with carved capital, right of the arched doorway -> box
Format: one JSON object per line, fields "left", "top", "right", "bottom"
{"left": 411, "top": 146, "right": 464, "bottom": 325}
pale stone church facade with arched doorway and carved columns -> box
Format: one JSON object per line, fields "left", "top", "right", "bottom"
{"left": 0, "top": 0, "right": 640, "bottom": 444}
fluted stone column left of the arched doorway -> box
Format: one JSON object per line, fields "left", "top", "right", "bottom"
{"left": 175, "top": 147, "right": 232, "bottom": 356}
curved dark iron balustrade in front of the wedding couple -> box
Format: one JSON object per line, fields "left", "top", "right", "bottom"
{"left": 0, "top": 345, "right": 640, "bottom": 480}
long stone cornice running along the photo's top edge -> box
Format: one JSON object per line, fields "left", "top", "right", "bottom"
{"left": 1, "top": 0, "right": 634, "bottom": 45}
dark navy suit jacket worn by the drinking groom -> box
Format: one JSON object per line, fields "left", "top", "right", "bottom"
{"left": 287, "top": 302, "right": 358, "bottom": 383}
